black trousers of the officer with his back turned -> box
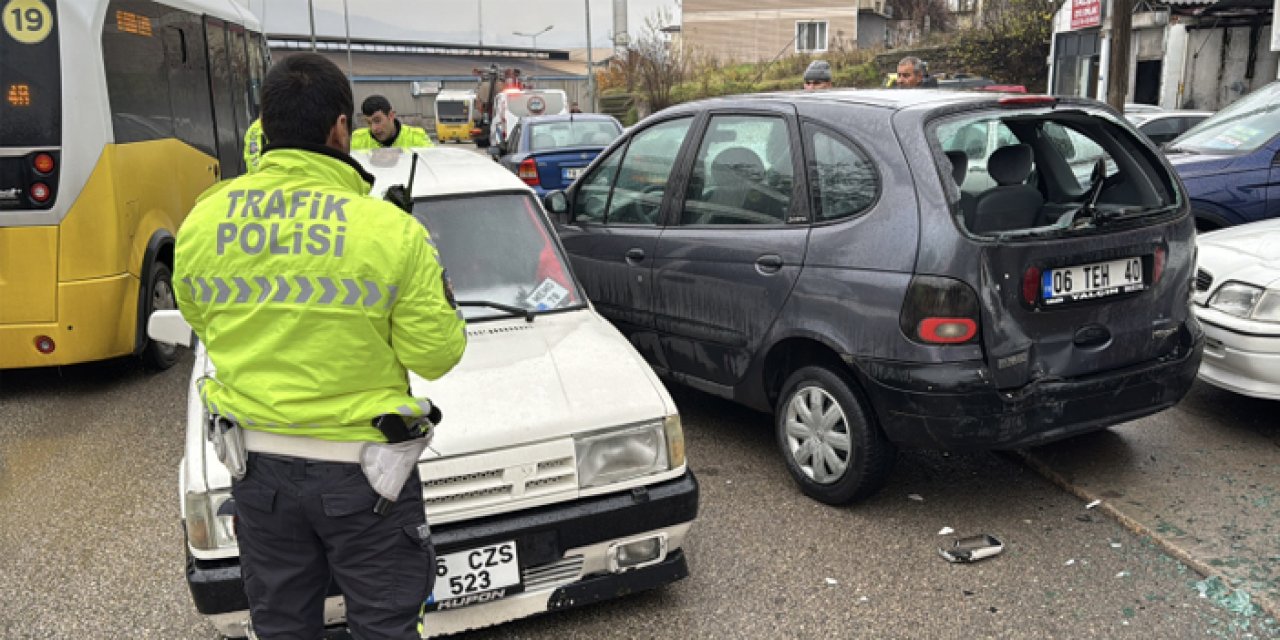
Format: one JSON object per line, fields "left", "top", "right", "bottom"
{"left": 232, "top": 453, "right": 435, "bottom": 640}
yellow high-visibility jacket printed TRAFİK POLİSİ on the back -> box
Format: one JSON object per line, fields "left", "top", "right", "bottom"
{"left": 174, "top": 147, "right": 466, "bottom": 442}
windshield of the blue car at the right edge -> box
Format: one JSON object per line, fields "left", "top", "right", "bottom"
{"left": 1170, "top": 82, "right": 1280, "bottom": 154}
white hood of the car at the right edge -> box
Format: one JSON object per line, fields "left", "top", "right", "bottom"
{"left": 1196, "top": 219, "right": 1280, "bottom": 287}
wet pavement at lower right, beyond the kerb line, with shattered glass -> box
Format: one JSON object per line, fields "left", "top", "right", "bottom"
{"left": 1027, "top": 383, "right": 1280, "bottom": 627}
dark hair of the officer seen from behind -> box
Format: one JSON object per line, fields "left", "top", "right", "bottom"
{"left": 262, "top": 52, "right": 355, "bottom": 145}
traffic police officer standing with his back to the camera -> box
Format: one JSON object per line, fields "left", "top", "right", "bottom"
{"left": 174, "top": 54, "right": 466, "bottom": 640}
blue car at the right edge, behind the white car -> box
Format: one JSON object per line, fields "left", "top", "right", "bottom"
{"left": 1165, "top": 82, "right": 1280, "bottom": 230}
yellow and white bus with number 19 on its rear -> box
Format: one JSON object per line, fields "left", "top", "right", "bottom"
{"left": 0, "top": 0, "right": 268, "bottom": 369}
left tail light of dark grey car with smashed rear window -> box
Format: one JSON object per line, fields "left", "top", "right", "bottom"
{"left": 899, "top": 275, "right": 979, "bottom": 344}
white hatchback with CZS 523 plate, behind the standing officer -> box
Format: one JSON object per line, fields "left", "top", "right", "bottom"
{"left": 148, "top": 148, "right": 698, "bottom": 637}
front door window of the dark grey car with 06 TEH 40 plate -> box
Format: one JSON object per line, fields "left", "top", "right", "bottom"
{"left": 604, "top": 118, "right": 692, "bottom": 224}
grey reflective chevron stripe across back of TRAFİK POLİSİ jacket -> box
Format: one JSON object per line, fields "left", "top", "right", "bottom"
{"left": 182, "top": 275, "right": 399, "bottom": 308}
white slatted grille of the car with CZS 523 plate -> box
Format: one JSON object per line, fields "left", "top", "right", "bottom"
{"left": 419, "top": 440, "right": 577, "bottom": 522}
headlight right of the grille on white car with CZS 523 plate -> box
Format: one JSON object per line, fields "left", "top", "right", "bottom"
{"left": 573, "top": 416, "right": 685, "bottom": 489}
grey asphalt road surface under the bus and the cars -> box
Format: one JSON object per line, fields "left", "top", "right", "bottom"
{"left": 0, "top": 357, "right": 1280, "bottom": 639}
